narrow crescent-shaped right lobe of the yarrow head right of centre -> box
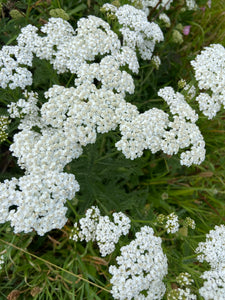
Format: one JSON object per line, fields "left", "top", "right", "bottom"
{"left": 158, "top": 87, "right": 205, "bottom": 166}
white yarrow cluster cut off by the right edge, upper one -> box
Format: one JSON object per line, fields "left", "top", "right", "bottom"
{"left": 191, "top": 44, "right": 225, "bottom": 119}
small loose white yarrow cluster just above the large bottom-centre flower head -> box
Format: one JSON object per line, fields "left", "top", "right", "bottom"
{"left": 71, "top": 206, "right": 130, "bottom": 256}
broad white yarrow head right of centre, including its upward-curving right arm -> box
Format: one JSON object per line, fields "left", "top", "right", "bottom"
{"left": 116, "top": 87, "right": 205, "bottom": 166}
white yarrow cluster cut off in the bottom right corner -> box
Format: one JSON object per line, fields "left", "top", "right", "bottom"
{"left": 196, "top": 225, "right": 225, "bottom": 300}
